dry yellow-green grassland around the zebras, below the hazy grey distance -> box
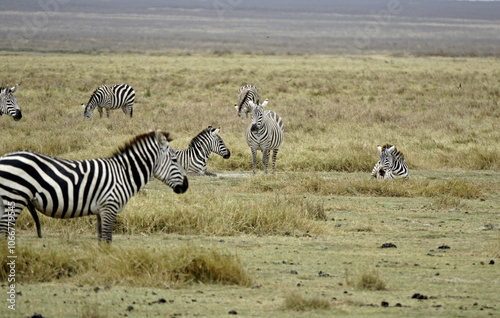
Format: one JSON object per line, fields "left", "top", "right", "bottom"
{"left": 0, "top": 51, "right": 500, "bottom": 317}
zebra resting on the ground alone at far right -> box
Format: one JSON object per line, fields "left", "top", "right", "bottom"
{"left": 371, "top": 144, "right": 409, "bottom": 180}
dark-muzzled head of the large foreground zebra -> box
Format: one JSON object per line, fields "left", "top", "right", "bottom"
{"left": 154, "top": 130, "right": 188, "bottom": 193}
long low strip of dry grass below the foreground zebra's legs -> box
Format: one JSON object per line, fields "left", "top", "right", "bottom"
{"left": 0, "top": 242, "right": 252, "bottom": 288}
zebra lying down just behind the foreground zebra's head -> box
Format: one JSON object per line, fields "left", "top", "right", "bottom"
{"left": 175, "top": 126, "right": 231, "bottom": 177}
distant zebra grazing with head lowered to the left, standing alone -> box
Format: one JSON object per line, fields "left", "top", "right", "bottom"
{"left": 82, "top": 84, "right": 135, "bottom": 119}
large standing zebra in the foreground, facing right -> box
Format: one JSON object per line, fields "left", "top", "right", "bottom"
{"left": 0, "top": 130, "right": 188, "bottom": 242}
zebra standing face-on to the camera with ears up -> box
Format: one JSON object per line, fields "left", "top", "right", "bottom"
{"left": 246, "top": 99, "right": 283, "bottom": 174}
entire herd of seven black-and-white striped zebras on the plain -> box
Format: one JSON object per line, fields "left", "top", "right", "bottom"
{"left": 0, "top": 84, "right": 408, "bottom": 242}
